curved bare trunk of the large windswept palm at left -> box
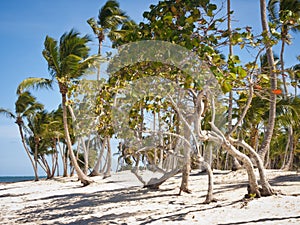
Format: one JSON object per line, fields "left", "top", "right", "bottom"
{"left": 59, "top": 87, "right": 93, "bottom": 186}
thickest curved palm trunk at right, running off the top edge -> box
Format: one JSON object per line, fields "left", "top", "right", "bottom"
{"left": 258, "top": 0, "right": 277, "bottom": 162}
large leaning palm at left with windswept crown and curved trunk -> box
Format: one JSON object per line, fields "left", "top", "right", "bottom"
{"left": 18, "top": 29, "right": 98, "bottom": 185}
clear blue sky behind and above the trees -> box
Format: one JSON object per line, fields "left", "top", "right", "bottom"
{"left": 0, "top": 0, "right": 300, "bottom": 176}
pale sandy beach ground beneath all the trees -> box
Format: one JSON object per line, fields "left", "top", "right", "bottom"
{"left": 0, "top": 170, "right": 300, "bottom": 225}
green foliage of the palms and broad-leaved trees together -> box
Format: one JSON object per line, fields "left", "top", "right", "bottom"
{"left": 5, "top": 0, "right": 300, "bottom": 176}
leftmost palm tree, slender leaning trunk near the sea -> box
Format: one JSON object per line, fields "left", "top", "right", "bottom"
{"left": 0, "top": 91, "right": 44, "bottom": 181}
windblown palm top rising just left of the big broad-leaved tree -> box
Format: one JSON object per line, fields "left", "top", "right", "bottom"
{"left": 87, "top": 0, "right": 127, "bottom": 80}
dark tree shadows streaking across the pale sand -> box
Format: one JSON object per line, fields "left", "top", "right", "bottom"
{"left": 16, "top": 171, "right": 300, "bottom": 225}
